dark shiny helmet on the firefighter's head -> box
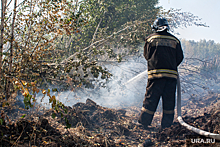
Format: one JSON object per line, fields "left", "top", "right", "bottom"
{"left": 151, "top": 17, "right": 170, "bottom": 32}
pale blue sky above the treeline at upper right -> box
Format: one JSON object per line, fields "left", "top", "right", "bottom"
{"left": 159, "top": 0, "right": 220, "bottom": 43}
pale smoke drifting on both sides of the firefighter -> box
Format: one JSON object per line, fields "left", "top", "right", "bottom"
{"left": 16, "top": 57, "right": 220, "bottom": 109}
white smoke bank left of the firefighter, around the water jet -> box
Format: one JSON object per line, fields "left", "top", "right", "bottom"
{"left": 23, "top": 57, "right": 147, "bottom": 108}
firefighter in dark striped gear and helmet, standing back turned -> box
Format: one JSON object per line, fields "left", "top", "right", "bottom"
{"left": 138, "top": 18, "right": 183, "bottom": 128}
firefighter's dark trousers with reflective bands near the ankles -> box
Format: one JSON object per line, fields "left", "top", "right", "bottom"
{"left": 139, "top": 78, "right": 177, "bottom": 128}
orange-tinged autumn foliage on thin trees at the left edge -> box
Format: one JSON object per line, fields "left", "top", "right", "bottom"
{"left": 0, "top": 0, "right": 86, "bottom": 126}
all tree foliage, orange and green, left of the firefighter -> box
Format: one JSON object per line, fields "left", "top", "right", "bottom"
{"left": 0, "top": 0, "right": 158, "bottom": 125}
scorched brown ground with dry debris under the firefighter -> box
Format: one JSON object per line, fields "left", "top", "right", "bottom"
{"left": 0, "top": 94, "right": 220, "bottom": 147}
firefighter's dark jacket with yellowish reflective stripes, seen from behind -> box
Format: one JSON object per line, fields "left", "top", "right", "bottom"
{"left": 144, "top": 31, "right": 183, "bottom": 79}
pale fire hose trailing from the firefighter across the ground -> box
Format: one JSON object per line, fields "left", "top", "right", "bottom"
{"left": 177, "top": 75, "right": 220, "bottom": 140}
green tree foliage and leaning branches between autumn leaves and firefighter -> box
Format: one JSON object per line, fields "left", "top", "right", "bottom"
{"left": 51, "top": 0, "right": 159, "bottom": 89}
